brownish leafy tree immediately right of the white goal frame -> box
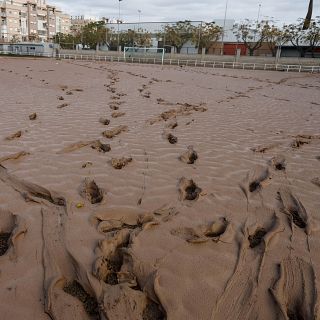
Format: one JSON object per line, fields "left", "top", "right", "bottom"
{"left": 161, "top": 20, "right": 194, "bottom": 53}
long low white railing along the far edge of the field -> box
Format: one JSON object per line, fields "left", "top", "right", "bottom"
{"left": 0, "top": 51, "right": 320, "bottom": 73}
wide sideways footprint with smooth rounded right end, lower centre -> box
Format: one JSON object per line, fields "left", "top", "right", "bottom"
{"left": 171, "top": 217, "right": 229, "bottom": 244}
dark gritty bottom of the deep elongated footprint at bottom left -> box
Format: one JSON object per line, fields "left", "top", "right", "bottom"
{"left": 63, "top": 280, "right": 99, "bottom": 316}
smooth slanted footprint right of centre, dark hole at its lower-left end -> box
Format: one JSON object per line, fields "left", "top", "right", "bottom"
{"left": 240, "top": 165, "right": 269, "bottom": 197}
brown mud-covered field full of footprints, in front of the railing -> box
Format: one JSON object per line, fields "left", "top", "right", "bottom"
{"left": 0, "top": 58, "right": 320, "bottom": 320}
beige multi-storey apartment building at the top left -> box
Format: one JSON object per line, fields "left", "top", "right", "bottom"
{"left": 0, "top": 0, "right": 71, "bottom": 42}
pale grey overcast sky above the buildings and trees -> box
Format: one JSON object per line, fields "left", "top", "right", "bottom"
{"left": 47, "top": 0, "right": 320, "bottom": 22}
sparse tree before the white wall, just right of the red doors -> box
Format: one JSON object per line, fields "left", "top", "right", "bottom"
{"left": 233, "top": 19, "right": 268, "bottom": 56}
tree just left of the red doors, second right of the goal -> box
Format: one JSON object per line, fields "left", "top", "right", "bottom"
{"left": 192, "top": 22, "right": 223, "bottom": 51}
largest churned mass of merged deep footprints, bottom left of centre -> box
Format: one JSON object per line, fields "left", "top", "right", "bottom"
{"left": 93, "top": 208, "right": 166, "bottom": 320}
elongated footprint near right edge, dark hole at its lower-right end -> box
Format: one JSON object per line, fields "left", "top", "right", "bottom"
{"left": 278, "top": 187, "right": 308, "bottom": 229}
